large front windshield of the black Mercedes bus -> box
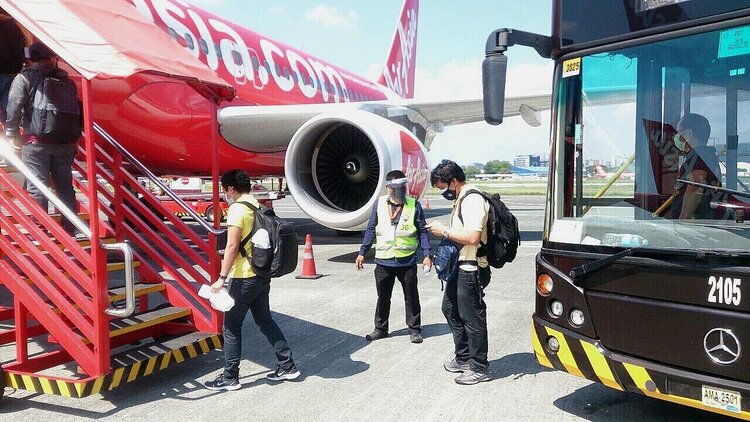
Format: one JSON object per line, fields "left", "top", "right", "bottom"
{"left": 546, "top": 22, "right": 750, "bottom": 250}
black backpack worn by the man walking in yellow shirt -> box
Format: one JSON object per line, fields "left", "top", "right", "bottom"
{"left": 238, "top": 201, "right": 298, "bottom": 278}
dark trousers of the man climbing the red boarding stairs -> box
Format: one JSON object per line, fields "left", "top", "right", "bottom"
{"left": 21, "top": 143, "right": 78, "bottom": 234}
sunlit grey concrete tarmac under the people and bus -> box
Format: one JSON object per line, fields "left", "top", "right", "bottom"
{"left": 0, "top": 197, "right": 736, "bottom": 422}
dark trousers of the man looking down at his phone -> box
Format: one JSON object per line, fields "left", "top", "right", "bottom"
{"left": 443, "top": 269, "right": 489, "bottom": 371}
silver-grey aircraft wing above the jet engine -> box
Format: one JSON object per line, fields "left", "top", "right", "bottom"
{"left": 219, "top": 94, "right": 550, "bottom": 152}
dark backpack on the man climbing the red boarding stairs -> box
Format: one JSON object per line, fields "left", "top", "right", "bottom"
{"left": 27, "top": 69, "right": 82, "bottom": 144}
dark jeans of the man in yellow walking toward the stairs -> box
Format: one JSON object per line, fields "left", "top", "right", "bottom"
{"left": 224, "top": 277, "right": 294, "bottom": 379}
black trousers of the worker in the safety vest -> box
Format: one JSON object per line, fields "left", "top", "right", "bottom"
{"left": 375, "top": 264, "right": 422, "bottom": 333}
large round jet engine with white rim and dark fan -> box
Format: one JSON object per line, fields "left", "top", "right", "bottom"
{"left": 284, "top": 110, "right": 429, "bottom": 230}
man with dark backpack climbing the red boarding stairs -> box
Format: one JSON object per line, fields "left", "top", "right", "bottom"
{"left": 5, "top": 41, "right": 82, "bottom": 235}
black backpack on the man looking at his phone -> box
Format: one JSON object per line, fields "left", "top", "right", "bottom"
{"left": 458, "top": 189, "right": 521, "bottom": 268}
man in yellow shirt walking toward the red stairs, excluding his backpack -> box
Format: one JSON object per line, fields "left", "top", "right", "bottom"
{"left": 206, "top": 170, "right": 300, "bottom": 391}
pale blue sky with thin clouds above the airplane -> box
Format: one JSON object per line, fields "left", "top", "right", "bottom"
{"left": 188, "top": 0, "right": 552, "bottom": 164}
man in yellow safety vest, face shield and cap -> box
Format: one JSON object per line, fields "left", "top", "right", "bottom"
{"left": 355, "top": 170, "right": 432, "bottom": 343}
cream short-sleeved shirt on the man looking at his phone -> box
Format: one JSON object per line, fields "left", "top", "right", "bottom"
{"left": 451, "top": 184, "right": 489, "bottom": 271}
